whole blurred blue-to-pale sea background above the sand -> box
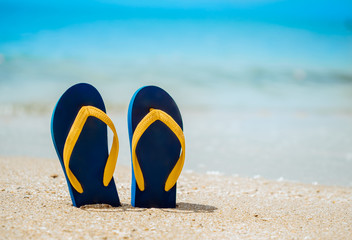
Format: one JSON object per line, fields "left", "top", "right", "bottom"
{"left": 0, "top": 0, "right": 352, "bottom": 186}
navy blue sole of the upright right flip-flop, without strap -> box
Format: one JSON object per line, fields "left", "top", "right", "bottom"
{"left": 128, "top": 86, "right": 183, "bottom": 208}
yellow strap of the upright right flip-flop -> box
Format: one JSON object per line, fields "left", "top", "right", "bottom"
{"left": 132, "top": 109, "right": 185, "bottom": 191}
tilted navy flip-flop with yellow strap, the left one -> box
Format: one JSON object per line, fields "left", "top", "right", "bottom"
{"left": 51, "top": 83, "right": 121, "bottom": 207}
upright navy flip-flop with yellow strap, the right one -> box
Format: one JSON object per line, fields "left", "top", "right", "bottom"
{"left": 128, "top": 86, "right": 185, "bottom": 208}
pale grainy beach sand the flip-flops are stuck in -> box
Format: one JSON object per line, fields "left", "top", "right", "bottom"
{"left": 0, "top": 157, "right": 352, "bottom": 239}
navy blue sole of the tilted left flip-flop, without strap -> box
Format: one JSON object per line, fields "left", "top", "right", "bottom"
{"left": 51, "top": 83, "right": 120, "bottom": 207}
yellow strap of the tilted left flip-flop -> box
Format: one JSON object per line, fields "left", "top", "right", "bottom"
{"left": 64, "top": 106, "right": 119, "bottom": 193}
